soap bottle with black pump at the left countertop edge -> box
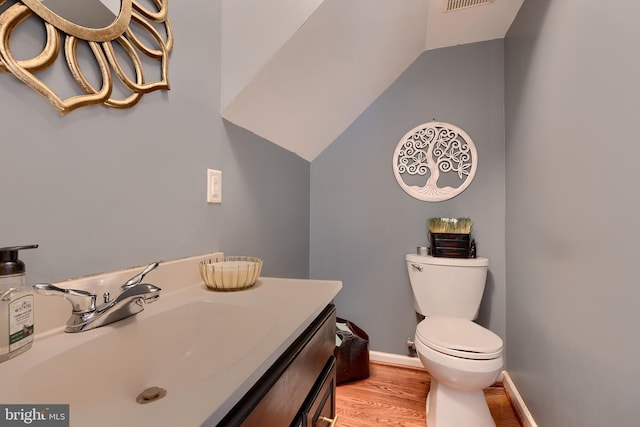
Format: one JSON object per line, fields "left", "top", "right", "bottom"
{"left": 0, "top": 245, "right": 38, "bottom": 362}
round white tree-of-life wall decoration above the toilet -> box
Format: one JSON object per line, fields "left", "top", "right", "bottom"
{"left": 393, "top": 121, "right": 478, "bottom": 202}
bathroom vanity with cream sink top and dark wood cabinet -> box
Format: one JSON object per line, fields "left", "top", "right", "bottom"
{"left": 0, "top": 255, "right": 342, "bottom": 427}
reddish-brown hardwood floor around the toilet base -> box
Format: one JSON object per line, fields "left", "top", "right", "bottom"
{"left": 336, "top": 362, "right": 521, "bottom": 427}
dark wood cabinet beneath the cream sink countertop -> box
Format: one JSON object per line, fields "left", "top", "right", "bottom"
{"left": 218, "top": 304, "right": 336, "bottom": 427}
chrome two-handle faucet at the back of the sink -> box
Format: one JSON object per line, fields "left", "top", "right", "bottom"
{"left": 33, "top": 262, "right": 161, "bottom": 332}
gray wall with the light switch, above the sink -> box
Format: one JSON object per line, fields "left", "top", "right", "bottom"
{"left": 0, "top": 0, "right": 310, "bottom": 283}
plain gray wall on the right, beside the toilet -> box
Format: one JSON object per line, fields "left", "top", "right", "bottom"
{"left": 505, "top": 0, "right": 640, "bottom": 427}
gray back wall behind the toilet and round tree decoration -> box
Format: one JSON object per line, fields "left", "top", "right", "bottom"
{"left": 310, "top": 40, "right": 505, "bottom": 354}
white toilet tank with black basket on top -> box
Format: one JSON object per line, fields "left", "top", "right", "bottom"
{"left": 406, "top": 254, "right": 489, "bottom": 320}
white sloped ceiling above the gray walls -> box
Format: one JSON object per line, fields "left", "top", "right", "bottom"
{"left": 221, "top": 0, "right": 524, "bottom": 162}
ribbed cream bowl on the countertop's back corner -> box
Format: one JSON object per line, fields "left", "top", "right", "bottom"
{"left": 200, "top": 256, "right": 262, "bottom": 291}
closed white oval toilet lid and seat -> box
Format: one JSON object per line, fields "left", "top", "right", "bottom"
{"left": 416, "top": 316, "right": 502, "bottom": 360}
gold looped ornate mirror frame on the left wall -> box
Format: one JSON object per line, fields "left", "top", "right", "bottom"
{"left": 0, "top": 0, "right": 173, "bottom": 115}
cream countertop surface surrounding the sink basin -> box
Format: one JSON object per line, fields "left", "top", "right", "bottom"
{"left": 0, "top": 256, "right": 342, "bottom": 427}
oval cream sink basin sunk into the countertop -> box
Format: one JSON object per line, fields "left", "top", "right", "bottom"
{"left": 20, "top": 301, "right": 271, "bottom": 410}
